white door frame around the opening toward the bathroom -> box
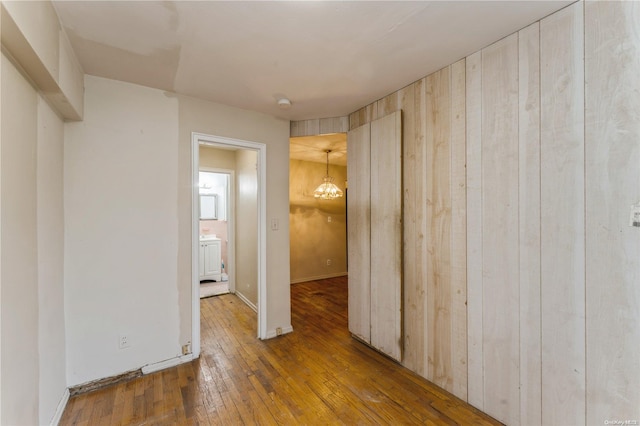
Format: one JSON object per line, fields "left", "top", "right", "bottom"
{"left": 191, "top": 132, "right": 267, "bottom": 357}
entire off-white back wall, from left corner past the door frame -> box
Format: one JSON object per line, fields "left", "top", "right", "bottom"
{"left": 64, "top": 76, "right": 291, "bottom": 385}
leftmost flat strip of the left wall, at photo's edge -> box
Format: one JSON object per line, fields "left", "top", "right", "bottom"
{"left": 0, "top": 50, "right": 39, "bottom": 424}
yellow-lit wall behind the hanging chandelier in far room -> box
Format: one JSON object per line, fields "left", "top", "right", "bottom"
{"left": 289, "top": 160, "right": 347, "bottom": 283}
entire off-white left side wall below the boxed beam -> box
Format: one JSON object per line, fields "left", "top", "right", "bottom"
{"left": 0, "top": 54, "right": 67, "bottom": 424}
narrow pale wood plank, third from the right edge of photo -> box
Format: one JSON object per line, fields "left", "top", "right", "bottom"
{"left": 518, "top": 22, "right": 542, "bottom": 426}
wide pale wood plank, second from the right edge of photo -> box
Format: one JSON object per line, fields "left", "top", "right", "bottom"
{"left": 540, "top": 3, "right": 585, "bottom": 424}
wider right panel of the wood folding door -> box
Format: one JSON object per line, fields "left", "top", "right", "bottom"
{"left": 368, "top": 111, "right": 402, "bottom": 360}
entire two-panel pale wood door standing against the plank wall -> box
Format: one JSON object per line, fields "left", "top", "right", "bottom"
{"left": 347, "top": 111, "right": 402, "bottom": 360}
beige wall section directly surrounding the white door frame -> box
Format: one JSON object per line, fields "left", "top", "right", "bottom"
{"left": 178, "top": 96, "right": 291, "bottom": 339}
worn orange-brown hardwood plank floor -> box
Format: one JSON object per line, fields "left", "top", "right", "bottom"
{"left": 60, "top": 278, "right": 500, "bottom": 426}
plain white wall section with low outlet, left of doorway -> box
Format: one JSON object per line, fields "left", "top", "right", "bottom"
{"left": 64, "top": 76, "right": 181, "bottom": 385}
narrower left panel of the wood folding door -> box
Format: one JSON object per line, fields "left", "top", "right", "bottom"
{"left": 347, "top": 124, "right": 371, "bottom": 343}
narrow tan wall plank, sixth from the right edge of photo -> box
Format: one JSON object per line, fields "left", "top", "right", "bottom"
{"left": 445, "top": 59, "right": 467, "bottom": 401}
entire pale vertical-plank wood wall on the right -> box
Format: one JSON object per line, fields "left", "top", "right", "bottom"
{"left": 350, "top": 2, "right": 640, "bottom": 425}
